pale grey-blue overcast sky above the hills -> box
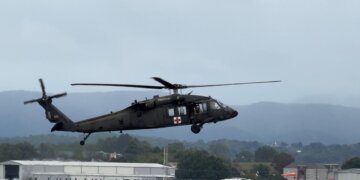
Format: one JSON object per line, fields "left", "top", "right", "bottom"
{"left": 0, "top": 0, "right": 360, "bottom": 105}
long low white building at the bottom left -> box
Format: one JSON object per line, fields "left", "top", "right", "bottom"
{"left": 0, "top": 160, "right": 175, "bottom": 180}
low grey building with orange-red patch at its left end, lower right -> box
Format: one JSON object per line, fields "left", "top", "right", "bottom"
{"left": 283, "top": 164, "right": 340, "bottom": 180}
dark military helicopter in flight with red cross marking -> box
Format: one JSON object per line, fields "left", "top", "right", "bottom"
{"left": 24, "top": 77, "right": 280, "bottom": 145}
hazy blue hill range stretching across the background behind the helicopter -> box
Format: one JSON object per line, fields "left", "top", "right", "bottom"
{"left": 0, "top": 91, "right": 360, "bottom": 144}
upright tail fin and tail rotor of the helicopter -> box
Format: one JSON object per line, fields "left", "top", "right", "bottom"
{"left": 24, "top": 79, "right": 74, "bottom": 131}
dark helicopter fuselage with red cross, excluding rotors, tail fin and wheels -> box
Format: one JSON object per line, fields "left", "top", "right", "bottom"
{"left": 61, "top": 94, "right": 237, "bottom": 133}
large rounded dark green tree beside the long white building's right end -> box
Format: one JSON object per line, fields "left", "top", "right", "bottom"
{"left": 176, "top": 150, "right": 232, "bottom": 179}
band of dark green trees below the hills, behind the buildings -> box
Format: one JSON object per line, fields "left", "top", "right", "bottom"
{"left": 0, "top": 134, "right": 360, "bottom": 179}
